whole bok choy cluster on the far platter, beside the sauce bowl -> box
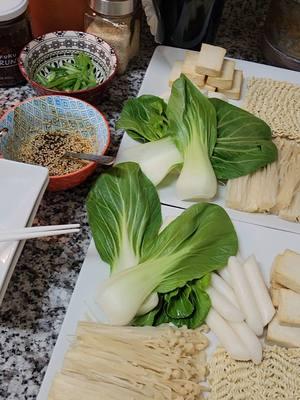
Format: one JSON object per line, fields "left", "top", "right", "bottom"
{"left": 117, "top": 75, "right": 277, "bottom": 200}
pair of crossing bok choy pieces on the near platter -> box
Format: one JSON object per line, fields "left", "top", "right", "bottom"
{"left": 87, "top": 163, "right": 238, "bottom": 325}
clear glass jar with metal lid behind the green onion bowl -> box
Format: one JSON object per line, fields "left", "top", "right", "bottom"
{"left": 85, "top": 0, "right": 140, "bottom": 74}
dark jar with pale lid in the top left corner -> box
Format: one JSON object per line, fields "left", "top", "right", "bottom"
{"left": 0, "top": 0, "right": 31, "bottom": 86}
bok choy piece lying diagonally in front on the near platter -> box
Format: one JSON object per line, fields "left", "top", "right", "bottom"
{"left": 97, "top": 203, "right": 238, "bottom": 325}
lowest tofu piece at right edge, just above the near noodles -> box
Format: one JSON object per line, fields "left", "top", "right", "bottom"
{"left": 266, "top": 315, "right": 300, "bottom": 347}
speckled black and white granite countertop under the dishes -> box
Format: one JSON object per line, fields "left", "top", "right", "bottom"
{"left": 0, "top": 0, "right": 269, "bottom": 400}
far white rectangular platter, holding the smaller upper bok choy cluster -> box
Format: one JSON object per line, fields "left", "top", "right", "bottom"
{"left": 119, "top": 46, "right": 300, "bottom": 233}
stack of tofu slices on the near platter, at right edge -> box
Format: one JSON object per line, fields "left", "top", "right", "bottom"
{"left": 267, "top": 250, "right": 300, "bottom": 347}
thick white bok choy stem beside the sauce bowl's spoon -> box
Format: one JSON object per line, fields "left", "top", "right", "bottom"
{"left": 117, "top": 137, "right": 183, "bottom": 186}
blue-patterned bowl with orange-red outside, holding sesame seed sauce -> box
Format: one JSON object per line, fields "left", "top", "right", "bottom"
{"left": 0, "top": 96, "right": 110, "bottom": 190}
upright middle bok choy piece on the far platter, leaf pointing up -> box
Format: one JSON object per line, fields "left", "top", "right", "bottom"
{"left": 167, "top": 75, "right": 217, "bottom": 200}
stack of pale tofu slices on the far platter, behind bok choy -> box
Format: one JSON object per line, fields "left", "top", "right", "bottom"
{"left": 169, "top": 43, "right": 243, "bottom": 100}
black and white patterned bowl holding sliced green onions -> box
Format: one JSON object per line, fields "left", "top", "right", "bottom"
{"left": 19, "top": 31, "right": 117, "bottom": 104}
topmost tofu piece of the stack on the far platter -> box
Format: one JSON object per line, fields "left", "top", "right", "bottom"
{"left": 196, "top": 43, "right": 226, "bottom": 76}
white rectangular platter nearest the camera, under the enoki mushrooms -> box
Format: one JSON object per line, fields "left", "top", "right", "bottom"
{"left": 37, "top": 206, "right": 300, "bottom": 400}
